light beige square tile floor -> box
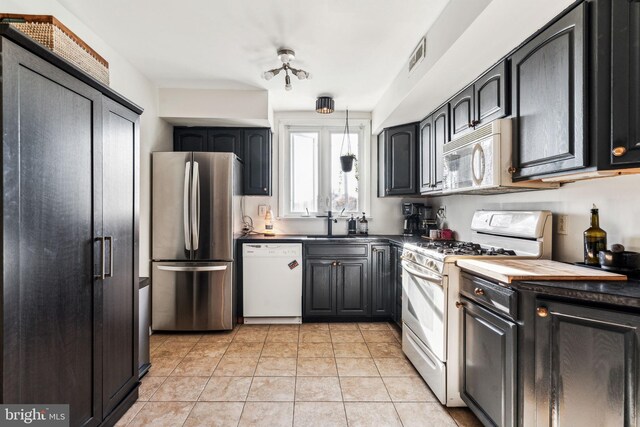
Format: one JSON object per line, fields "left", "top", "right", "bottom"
{"left": 117, "top": 323, "right": 481, "bottom": 427}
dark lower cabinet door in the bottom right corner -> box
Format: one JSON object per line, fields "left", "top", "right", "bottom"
{"left": 535, "top": 299, "right": 640, "bottom": 426}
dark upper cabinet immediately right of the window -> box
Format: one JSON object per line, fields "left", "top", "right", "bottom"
{"left": 378, "top": 123, "right": 417, "bottom": 197}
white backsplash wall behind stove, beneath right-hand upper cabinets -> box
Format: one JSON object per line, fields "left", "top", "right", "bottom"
{"left": 431, "top": 175, "right": 640, "bottom": 262}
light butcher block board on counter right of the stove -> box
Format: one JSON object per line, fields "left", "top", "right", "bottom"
{"left": 457, "top": 258, "right": 627, "bottom": 283}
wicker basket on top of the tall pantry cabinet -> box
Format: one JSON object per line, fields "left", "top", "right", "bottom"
{"left": 0, "top": 13, "right": 109, "bottom": 85}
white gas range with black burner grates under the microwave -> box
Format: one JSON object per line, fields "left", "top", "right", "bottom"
{"left": 402, "top": 211, "right": 552, "bottom": 406}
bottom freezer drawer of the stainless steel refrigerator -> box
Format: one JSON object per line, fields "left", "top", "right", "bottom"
{"left": 151, "top": 262, "right": 235, "bottom": 331}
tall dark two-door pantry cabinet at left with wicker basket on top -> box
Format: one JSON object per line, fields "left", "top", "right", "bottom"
{"left": 0, "top": 25, "right": 142, "bottom": 426}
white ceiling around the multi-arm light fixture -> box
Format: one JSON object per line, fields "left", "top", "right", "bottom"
{"left": 59, "top": 0, "right": 449, "bottom": 111}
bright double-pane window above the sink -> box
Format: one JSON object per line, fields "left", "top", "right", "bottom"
{"left": 279, "top": 120, "right": 369, "bottom": 217}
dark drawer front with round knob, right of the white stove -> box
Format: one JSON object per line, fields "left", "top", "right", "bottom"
{"left": 460, "top": 273, "right": 518, "bottom": 319}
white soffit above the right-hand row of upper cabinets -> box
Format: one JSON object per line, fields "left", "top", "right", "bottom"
{"left": 372, "top": 0, "right": 574, "bottom": 133}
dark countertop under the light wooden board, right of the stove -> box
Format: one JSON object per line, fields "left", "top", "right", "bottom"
{"left": 511, "top": 280, "right": 640, "bottom": 308}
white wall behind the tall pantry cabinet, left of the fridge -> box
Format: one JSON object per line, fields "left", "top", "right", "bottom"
{"left": 0, "top": 0, "right": 172, "bottom": 276}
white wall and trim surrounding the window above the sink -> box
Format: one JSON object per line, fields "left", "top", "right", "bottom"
{"left": 244, "top": 112, "right": 402, "bottom": 235}
